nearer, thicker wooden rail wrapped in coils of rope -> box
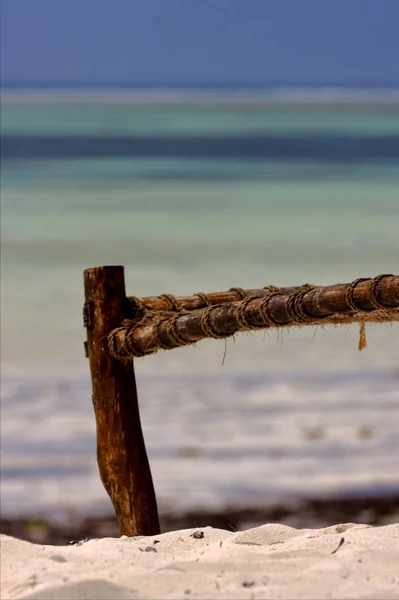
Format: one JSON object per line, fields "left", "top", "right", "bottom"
{"left": 108, "top": 275, "right": 399, "bottom": 360}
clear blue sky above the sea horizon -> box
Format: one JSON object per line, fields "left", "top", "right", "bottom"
{"left": 0, "top": 0, "right": 399, "bottom": 85}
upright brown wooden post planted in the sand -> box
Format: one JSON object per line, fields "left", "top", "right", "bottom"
{"left": 84, "top": 266, "right": 160, "bottom": 536}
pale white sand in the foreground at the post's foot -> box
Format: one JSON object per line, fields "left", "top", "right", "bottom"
{"left": 1, "top": 524, "right": 399, "bottom": 600}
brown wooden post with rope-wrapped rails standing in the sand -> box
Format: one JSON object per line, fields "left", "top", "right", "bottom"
{"left": 83, "top": 266, "right": 399, "bottom": 536}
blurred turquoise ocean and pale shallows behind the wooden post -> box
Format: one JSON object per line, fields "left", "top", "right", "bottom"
{"left": 1, "top": 89, "right": 399, "bottom": 515}
